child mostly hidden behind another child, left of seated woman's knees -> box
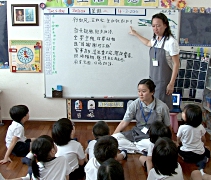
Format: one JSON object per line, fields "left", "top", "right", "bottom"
{"left": 85, "top": 121, "right": 127, "bottom": 161}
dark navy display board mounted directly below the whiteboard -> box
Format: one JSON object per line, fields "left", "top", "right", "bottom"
{"left": 66, "top": 99, "right": 134, "bottom": 122}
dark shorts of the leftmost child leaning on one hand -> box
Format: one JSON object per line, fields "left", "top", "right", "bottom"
{"left": 12, "top": 139, "right": 31, "bottom": 157}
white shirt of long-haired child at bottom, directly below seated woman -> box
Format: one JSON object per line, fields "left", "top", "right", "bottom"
{"left": 147, "top": 163, "right": 184, "bottom": 180}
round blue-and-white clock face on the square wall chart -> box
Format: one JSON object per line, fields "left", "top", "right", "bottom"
{"left": 17, "top": 47, "right": 34, "bottom": 64}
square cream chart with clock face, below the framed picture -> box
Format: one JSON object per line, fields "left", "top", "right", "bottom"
{"left": 9, "top": 40, "right": 42, "bottom": 72}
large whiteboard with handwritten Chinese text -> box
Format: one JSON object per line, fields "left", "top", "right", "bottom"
{"left": 43, "top": 7, "right": 178, "bottom": 98}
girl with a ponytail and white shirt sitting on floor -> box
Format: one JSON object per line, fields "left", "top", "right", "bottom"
{"left": 32, "top": 135, "right": 71, "bottom": 180}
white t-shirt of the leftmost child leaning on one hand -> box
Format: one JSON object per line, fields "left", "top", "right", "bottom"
{"left": 5, "top": 121, "right": 26, "bottom": 148}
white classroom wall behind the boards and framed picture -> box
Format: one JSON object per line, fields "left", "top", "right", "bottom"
{"left": 0, "top": 0, "right": 211, "bottom": 121}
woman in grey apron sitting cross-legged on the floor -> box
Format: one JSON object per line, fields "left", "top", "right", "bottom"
{"left": 112, "top": 79, "right": 171, "bottom": 153}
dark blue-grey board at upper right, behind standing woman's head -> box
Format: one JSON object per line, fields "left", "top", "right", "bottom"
{"left": 179, "top": 7, "right": 211, "bottom": 47}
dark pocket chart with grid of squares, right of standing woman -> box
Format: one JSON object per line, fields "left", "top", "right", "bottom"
{"left": 174, "top": 51, "right": 211, "bottom": 103}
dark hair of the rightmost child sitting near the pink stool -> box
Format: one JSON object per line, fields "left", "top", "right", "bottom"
{"left": 183, "top": 104, "right": 202, "bottom": 127}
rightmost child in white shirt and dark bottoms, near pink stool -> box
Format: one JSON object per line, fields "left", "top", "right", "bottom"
{"left": 177, "top": 104, "right": 210, "bottom": 166}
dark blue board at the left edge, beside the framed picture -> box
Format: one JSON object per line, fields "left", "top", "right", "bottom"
{"left": 0, "top": 1, "right": 9, "bottom": 69}
